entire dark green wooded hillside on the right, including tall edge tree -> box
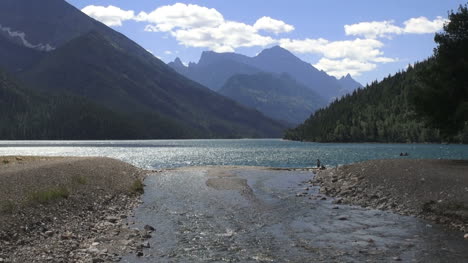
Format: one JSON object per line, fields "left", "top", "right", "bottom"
{"left": 285, "top": 5, "right": 468, "bottom": 143}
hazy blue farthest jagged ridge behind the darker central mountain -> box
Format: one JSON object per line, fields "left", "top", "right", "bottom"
{"left": 168, "top": 46, "right": 362, "bottom": 102}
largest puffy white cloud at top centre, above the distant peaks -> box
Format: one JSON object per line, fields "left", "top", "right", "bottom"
{"left": 135, "top": 3, "right": 282, "bottom": 52}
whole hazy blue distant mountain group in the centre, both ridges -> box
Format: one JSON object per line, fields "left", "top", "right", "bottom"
{"left": 168, "top": 46, "right": 362, "bottom": 125}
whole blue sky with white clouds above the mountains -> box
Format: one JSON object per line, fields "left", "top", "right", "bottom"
{"left": 67, "top": 0, "right": 466, "bottom": 85}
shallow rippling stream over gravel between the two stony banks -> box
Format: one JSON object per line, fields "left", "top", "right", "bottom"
{"left": 122, "top": 167, "right": 468, "bottom": 262}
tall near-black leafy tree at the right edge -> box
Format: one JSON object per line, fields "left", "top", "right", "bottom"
{"left": 414, "top": 5, "right": 468, "bottom": 136}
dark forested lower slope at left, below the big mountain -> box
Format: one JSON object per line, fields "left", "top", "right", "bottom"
{"left": 0, "top": 71, "right": 190, "bottom": 140}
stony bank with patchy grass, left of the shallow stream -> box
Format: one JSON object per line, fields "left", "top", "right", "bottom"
{"left": 0, "top": 156, "right": 152, "bottom": 262}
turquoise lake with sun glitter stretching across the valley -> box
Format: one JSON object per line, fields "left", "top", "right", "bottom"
{"left": 0, "top": 139, "right": 468, "bottom": 169}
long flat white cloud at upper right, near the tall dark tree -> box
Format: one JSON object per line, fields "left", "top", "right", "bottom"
{"left": 344, "top": 16, "right": 448, "bottom": 38}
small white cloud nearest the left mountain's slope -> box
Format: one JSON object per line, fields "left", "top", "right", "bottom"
{"left": 81, "top": 5, "right": 135, "bottom": 26}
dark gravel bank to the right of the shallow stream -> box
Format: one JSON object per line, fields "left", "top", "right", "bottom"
{"left": 311, "top": 159, "right": 468, "bottom": 232}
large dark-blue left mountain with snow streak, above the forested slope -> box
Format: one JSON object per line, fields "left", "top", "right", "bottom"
{"left": 0, "top": 0, "right": 285, "bottom": 139}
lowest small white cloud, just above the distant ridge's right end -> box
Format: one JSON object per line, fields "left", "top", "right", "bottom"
{"left": 313, "top": 58, "right": 377, "bottom": 78}
